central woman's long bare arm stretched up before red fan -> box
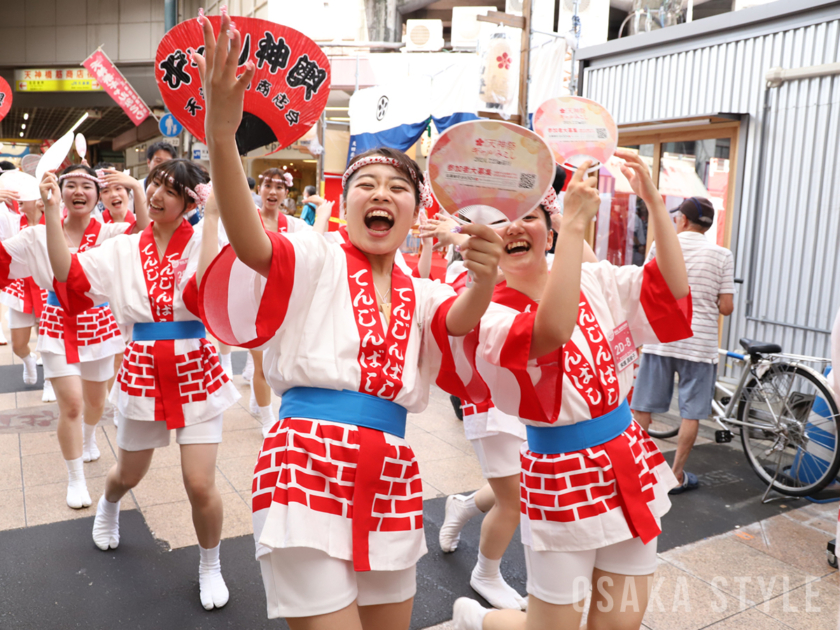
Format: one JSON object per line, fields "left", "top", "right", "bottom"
{"left": 193, "top": 12, "right": 272, "bottom": 276}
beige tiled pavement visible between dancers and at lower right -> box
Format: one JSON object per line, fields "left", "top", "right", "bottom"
{"left": 0, "top": 317, "right": 840, "bottom": 630}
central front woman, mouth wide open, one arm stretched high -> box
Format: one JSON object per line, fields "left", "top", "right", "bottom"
{"left": 193, "top": 14, "right": 500, "bottom": 630}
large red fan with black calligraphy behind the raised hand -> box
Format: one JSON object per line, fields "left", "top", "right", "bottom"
{"left": 155, "top": 16, "right": 330, "bottom": 154}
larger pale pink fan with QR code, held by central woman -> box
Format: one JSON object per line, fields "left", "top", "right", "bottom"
{"left": 428, "top": 120, "right": 554, "bottom": 225}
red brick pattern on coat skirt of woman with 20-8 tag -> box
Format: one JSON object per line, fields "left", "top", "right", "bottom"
{"left": 520, "top": 422, "right": 665, "bottom": 523}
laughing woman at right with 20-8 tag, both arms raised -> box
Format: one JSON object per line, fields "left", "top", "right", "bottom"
{"left": 441, "top": 151, "right": 691, "bottom": 630}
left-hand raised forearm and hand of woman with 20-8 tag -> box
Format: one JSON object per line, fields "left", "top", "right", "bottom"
{"left": 530, "top": 162, "right": 601, "bottom": 359}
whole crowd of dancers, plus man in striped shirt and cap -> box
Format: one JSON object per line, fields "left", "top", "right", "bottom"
{"left": 0, "top": 9, "right": 840, "bottom": 630}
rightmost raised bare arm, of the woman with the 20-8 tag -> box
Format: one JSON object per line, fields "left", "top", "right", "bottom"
{"left": 615, "top": 149, "right": 689, "bottom": 300}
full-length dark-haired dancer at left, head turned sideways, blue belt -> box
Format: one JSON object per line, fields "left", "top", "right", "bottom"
{"left": 41, "top": 159, "right": 239, "bottom": 610}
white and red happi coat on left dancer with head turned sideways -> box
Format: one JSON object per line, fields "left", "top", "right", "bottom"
{"left": 56, "top": 221, "right": 239, "bottom": 429}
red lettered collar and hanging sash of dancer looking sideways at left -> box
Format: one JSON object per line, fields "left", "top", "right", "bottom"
{"left": 140, "top": 220, "right": 193, "bottom": 429}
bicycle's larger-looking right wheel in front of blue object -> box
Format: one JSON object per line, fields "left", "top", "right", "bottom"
{"left": 738, "top": 363, "right": 840, "bottom": 497}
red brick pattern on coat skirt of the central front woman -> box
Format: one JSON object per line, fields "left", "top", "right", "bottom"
{"left": 252, "top": 418, "right": 423, "bottom": 532}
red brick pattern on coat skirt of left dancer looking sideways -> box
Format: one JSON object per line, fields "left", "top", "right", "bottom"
{"left": 117, "top": 339, "right": 227, "bottom": 405}
